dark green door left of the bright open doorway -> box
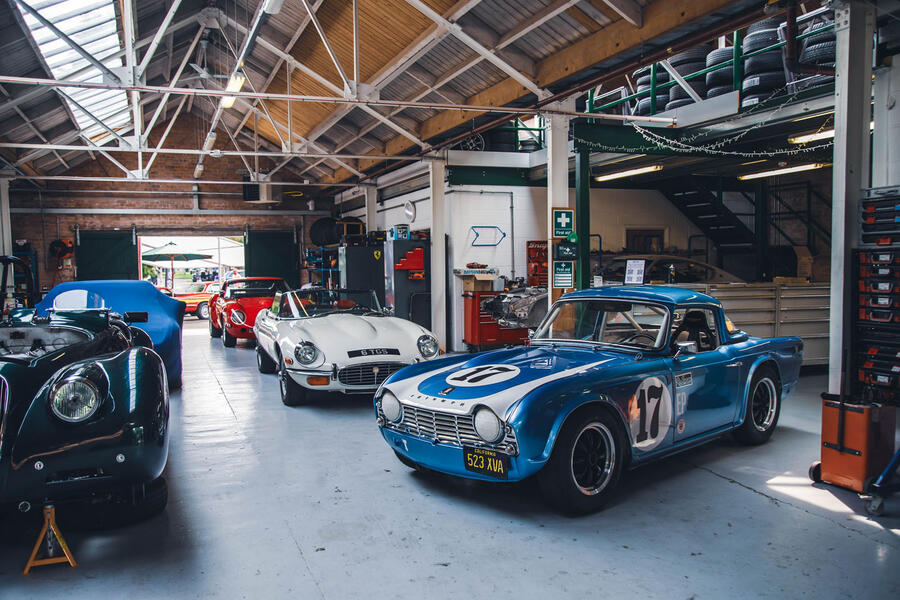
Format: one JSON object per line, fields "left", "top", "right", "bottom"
{"left": 75, "top": 230, "right": 140, "bottom": 281}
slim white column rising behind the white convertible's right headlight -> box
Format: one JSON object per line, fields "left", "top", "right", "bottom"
{"left": 428, "top": 160, "right": 448, "bottom": 347}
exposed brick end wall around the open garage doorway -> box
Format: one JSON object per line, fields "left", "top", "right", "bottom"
{"left": 10, "top": 115, "right": 316, "bottom": 288}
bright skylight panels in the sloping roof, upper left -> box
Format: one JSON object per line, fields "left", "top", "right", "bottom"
{"left": 17, "top": 0, "right": 131, "bottom": 141}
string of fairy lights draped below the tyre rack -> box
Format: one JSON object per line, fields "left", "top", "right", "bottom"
{"left": 575, "top": 86, "right": 833, "bottom": 160}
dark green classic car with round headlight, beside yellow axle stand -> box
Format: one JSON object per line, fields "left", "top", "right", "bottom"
{"left": 0, "top": 257, "right": 169, "bottom": 516}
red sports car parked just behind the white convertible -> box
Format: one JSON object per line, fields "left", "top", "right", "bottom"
{"left": 209, "top": 277, "right": 289, "bottom": 348}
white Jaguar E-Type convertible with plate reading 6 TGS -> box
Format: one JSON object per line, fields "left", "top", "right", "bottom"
{"left": 253, "top": 288, "right": 440, "bottom": 406}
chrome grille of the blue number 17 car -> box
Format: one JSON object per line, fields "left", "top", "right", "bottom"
{"left": 378, "top": 402, "right": 518, "bottom": 454}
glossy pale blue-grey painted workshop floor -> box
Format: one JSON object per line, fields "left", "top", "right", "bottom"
{"left": 0, "top": 318, "right": 900, "bottom": 600}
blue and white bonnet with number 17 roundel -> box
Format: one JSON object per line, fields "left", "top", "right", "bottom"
{"left": 385, "top": 346, "right": 634, "bottom": 416}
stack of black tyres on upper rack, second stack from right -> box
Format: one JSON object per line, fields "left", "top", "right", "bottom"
{"left": 741, "top": 19, "right": 787, "bottom": 108}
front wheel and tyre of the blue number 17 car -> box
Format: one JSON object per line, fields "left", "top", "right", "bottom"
{"left": 538, "top": 407, "right": 627, "bottom": 514}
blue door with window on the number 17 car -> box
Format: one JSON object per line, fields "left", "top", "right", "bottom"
{"left": 672, "top": 307, "right": 742, "bottom": 444}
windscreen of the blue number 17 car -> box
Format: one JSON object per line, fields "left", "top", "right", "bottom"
{"left": 533, "top": 299, "right": 669, "bottom": 350}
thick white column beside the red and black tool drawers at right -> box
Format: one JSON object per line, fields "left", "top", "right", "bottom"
{"left": 828, "top": 2, "right": 875, "bottom": 394}
